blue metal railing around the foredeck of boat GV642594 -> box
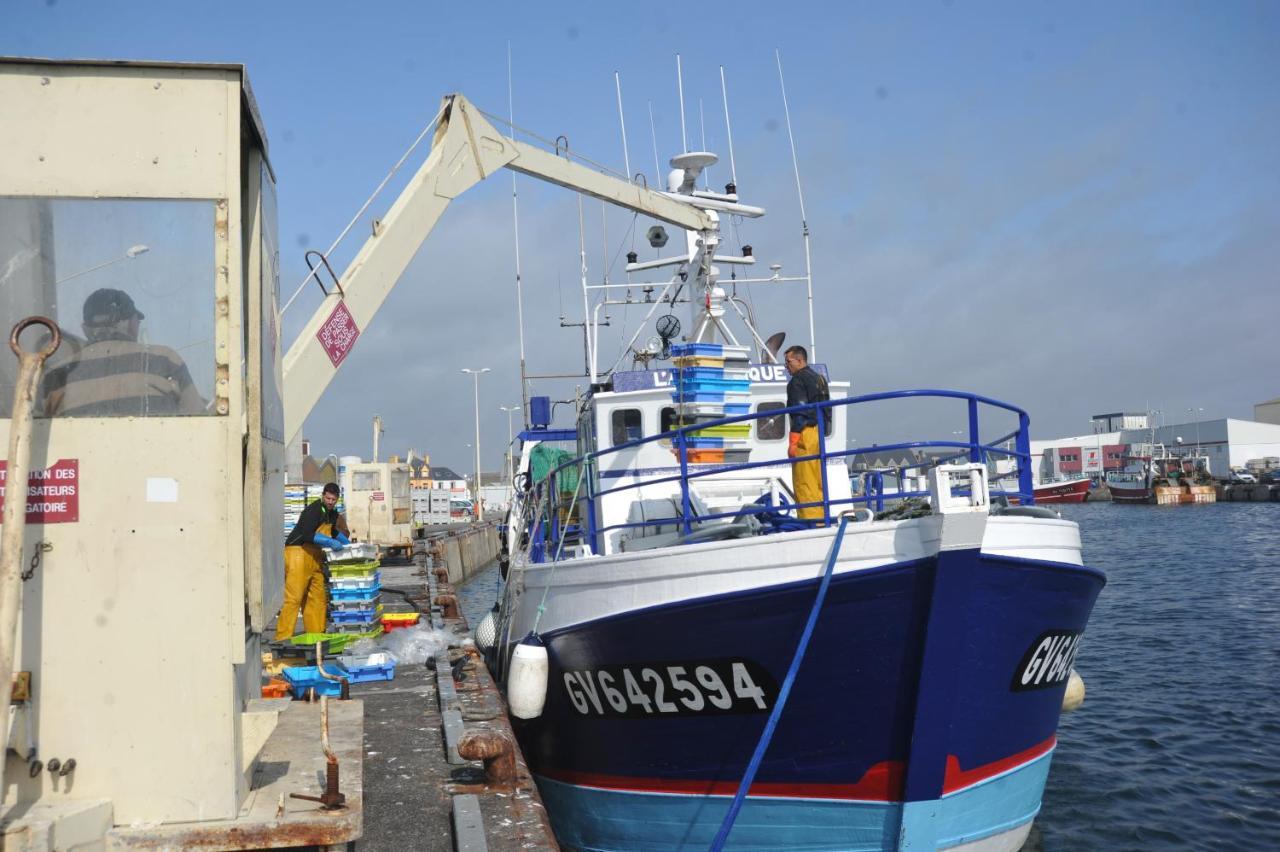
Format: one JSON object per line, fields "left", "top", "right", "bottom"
{"left": 526, "top": 390, "right": 1034, "bottom": 562}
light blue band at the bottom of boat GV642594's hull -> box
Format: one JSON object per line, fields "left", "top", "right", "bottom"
{"left": 538, "top": 752, "right": 1052, "bottom": 852}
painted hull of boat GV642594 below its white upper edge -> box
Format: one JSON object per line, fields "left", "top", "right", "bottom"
{"left": 506, "top": 550, "right": 1105, "bottom": 849}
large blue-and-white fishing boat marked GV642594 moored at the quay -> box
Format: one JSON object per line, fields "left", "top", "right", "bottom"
{"left": 481, "top": 133, "right": 1105, "bottom": 849}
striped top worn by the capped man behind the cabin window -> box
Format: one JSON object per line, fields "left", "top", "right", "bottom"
{"left": 44, "top": 340, "right": 207, "bottom": 417}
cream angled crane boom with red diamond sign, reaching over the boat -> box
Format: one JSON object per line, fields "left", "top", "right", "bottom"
{"left": 284, "top": 93, "right": 717, "bottom": 443}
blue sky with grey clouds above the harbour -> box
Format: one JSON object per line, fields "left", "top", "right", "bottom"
{"left": 0, "top": 0, "right": 1280, "bottom": 472}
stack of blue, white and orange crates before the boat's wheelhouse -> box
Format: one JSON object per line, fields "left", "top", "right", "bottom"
{"left": 671, "top": 343, "right": 751, "bottom": 464}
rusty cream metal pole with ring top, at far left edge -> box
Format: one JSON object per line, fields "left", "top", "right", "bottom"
{"left": 0, "top": 316, "right": 61, "bottom": 785}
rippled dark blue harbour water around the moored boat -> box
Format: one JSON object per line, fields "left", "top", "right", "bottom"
{"left": 461, "top": 503, "right": 1280, "bottom": 852}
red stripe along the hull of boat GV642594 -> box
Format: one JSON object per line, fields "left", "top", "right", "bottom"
{"left": 540, "top": 737, "right": 1056, "bottom": 802}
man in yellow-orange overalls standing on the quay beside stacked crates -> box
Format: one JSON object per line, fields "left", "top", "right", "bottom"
{"left": 275, "top": 482, "right": 349, "bottom": 634}
